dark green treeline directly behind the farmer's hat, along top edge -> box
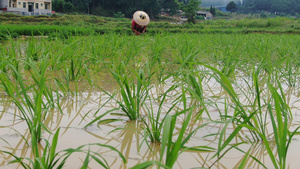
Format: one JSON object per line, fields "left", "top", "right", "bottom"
{"left": 52, "top": 0, "right": 180, "bottom": 18}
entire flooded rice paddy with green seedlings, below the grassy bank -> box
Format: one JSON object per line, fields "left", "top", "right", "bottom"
{"left": 0, "top": 15, "right": 300, "bottom": 169}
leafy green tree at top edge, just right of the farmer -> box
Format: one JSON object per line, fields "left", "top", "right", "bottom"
{"left": 178, "top": 0, "right": 201, "bottom": 23}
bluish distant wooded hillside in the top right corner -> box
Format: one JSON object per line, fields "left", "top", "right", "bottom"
{"left": 237, "top": 0, "right": 300, "bottom": 15}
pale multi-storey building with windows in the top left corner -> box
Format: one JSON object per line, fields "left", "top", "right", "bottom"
{"left": 0, "top": 0, "right": 52, "bottom": 15}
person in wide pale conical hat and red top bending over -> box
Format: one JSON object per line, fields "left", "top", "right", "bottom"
{"left": 131, "top": 11, "right": 150, "bottom": 35}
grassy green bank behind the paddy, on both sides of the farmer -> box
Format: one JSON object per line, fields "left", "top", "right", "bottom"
{"left": 0, "top": 14, "right": 300, "bottom": 39}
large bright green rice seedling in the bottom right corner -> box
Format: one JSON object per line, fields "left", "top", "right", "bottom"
{"left": 239, "top": 81, "right": 300, "bottom": 169}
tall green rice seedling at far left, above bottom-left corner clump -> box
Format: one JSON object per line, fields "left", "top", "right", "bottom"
{"left": 1, "top": 56, "right": 50, "bottom": 143}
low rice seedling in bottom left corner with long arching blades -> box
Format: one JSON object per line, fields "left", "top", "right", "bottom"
{"left": 2, "top": 128, "right": 126, "bottom": 169}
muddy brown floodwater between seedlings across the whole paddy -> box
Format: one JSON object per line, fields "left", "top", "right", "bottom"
{"left": 0, "top": 33, "right": 300, "bottom": 169}
